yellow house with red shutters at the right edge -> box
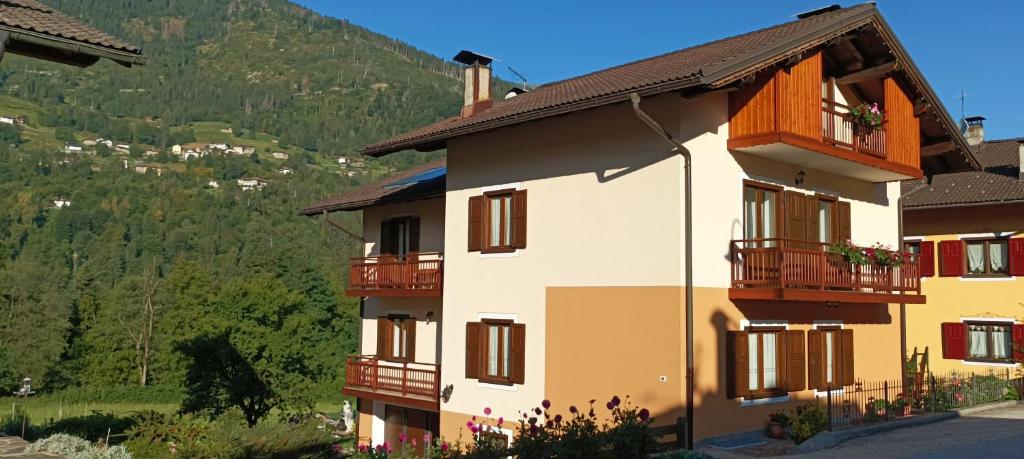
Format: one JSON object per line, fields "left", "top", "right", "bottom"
{"left": 903, "top": 128, "right": 1024, "bottom": 373}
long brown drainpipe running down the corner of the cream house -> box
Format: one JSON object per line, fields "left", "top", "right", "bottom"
{"left": 630, "top": 92, "right": 693, "bottom": 449}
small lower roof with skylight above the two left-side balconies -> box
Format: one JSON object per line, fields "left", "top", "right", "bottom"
{"left": 299, "top": 159, "right": 447, "bottom": 215}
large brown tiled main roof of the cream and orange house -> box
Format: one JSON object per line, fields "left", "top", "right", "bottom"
{"left": 362, "top": 3, "right": 976, "bottom": 175}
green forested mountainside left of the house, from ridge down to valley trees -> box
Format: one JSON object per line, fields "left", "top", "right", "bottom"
{"left": 0, "top": 0, "right": 471, "bottom": 407}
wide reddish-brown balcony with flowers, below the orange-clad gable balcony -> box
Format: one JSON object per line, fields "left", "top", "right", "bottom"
{"left": 729, "top": 238, "right": 925, "bottom": 304}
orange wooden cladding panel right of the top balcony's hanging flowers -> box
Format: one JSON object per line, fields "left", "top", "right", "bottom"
{"left": 884, "top": 77, "right": 921, "bottom": 169}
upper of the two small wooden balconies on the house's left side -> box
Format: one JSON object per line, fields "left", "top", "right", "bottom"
{"left": 345, "top": 252, "right": 444, "bottom": 298}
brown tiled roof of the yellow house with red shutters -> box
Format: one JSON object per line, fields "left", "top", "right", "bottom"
{"left": 903, "top": 138, "right": 1024, "bottom": 209}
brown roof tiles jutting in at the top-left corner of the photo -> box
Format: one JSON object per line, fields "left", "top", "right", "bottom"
{"left": 0, "top": 0, "right": 141, "bottom": 64}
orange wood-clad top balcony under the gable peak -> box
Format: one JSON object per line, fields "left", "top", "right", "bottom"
{"left": 728, "top": 48, "right": 924, "bottom": 182}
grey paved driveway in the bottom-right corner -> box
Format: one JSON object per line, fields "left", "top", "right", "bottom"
{"left": 800, "top": 405, "right": 1024, "bottom": 459}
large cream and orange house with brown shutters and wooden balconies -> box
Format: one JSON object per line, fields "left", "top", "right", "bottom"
{"left": 302, "top": 4, "right": 979, "bottom": 445}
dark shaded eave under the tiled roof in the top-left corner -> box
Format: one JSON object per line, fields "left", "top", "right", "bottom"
{"left": 0, "top": 25, "right": 145, "bottom": 67}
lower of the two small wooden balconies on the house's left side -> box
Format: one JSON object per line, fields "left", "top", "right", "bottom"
{"left": 341, "top": 356, "right": 441, "bottom": 412}
